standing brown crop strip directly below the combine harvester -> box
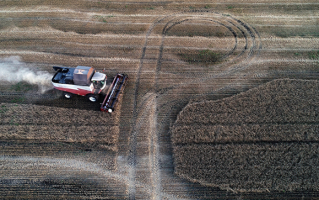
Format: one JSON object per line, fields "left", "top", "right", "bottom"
{"left": 0, "top": 103, "right": 119, "bottom": 151}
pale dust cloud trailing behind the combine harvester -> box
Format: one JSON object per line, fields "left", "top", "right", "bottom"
{"left": 0, "top": 56, "right": 53, "bottom": 93}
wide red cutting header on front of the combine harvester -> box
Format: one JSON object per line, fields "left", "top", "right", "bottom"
{"left": 101, "top": 74, "right": 128, "bottom": 113}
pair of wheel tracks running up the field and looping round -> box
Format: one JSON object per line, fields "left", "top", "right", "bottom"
{"left": 128, "top": 10, "right": 264, "bottom": 199}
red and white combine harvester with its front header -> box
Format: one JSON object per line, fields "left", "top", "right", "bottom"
{"left": 52, "top": 66, "right": 128, "bottom": 113}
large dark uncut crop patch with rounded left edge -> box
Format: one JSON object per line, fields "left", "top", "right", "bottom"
{"left": 171, "top": 79, "right": 319, "bottom": 191}
